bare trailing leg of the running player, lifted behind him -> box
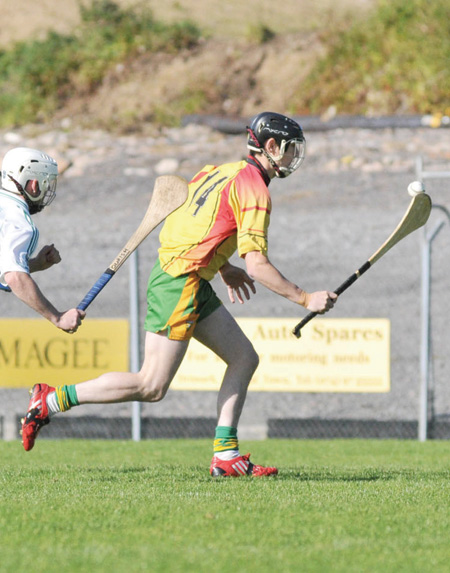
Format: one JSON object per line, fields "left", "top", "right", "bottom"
{"left": 76, "top": 332, "right": 188, "bottom": 404}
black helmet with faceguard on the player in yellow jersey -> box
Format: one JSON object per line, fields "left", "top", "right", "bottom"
{"left": 247, "top": 111, "right": 306, "bottom": 177}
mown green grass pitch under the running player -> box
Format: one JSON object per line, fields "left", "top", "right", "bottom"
{"left": 0, "top": 440, "right": 450, "bottom": 573}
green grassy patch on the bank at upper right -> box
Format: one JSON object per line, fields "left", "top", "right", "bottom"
{"left": 292, "top": 0, "right": 450, "bottom": 114}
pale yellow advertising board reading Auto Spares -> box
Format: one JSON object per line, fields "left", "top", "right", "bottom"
{"left": 171, "top": 318, "right": 390, "bottom": 392}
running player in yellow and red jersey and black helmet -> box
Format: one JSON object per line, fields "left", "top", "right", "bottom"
{"left": 22, "top": 112, "right": 337, "bottom": 477}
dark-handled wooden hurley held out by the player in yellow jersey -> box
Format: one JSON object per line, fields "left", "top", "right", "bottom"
{"left": 292, "top": 184, "right": 431, "bottom": 338}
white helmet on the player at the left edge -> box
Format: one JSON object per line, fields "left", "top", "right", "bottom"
{"left": 2, "top": 147, "right": 58, "bottom": 214}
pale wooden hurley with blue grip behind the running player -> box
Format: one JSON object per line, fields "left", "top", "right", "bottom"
{"left": 77, "top": 175, "right": 188, "bottom": 310}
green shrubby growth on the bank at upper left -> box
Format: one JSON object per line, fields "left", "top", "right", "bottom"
{"left": 0, "top": 0, "right": 200, "bottom": 127}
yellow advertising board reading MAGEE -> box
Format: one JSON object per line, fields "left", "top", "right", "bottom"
{"left": 0, "top": 318, "right": 129, "bottom": 388}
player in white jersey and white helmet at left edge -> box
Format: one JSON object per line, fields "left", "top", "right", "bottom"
{"left": 0, "top": 147, "right": 85, "bottom": 333}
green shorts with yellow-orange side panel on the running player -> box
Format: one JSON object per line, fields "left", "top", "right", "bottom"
{"left": 144, "top": 260, "right": 222, "bottom": 340}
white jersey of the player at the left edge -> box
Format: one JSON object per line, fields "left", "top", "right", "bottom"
{"left": 0, "top": 189, "right": 39, "bottom": 285}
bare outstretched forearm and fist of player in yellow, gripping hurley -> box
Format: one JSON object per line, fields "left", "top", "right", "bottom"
{"left": 245, "top": 251, "right": 337, "bottom": 314}
